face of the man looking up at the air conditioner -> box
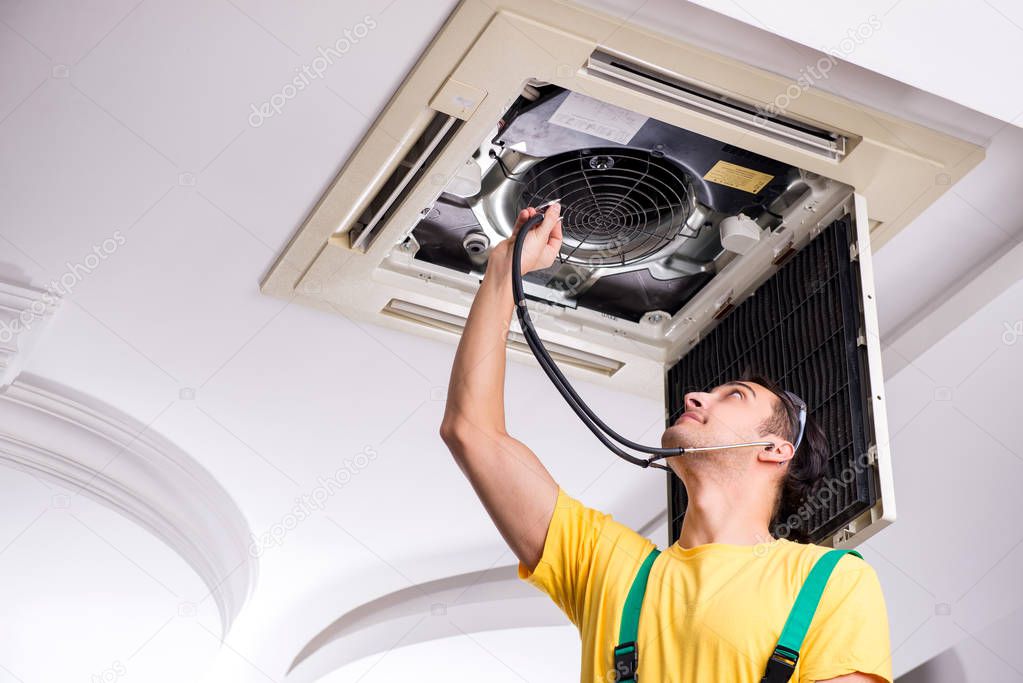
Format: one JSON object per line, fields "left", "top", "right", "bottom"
{"left": 661, "top": 380, "right": 784, "bottom": 457}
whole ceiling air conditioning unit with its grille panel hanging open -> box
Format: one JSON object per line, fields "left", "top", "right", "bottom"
{"left": 262, "top": 0, "right": 983, "bottom": 543}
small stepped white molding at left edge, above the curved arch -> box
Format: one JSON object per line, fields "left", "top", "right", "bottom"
{"left": 0, "top": 280, "right": 60, "bottom": 386}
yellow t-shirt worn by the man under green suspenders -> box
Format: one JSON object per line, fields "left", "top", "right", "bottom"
{"left": 519, "top": 488, "right": 892, "bottom": 683}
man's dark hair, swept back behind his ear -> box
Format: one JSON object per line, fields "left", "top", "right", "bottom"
{"left": 740, "top": 368, "right": 830, "bottom": 543}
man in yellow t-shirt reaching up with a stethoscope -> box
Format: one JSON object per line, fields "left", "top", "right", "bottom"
{"left": 440, "top": 204, "right": 892, "bottom": 683}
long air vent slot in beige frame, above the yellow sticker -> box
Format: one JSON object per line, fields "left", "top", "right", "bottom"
{"left": 586, "top": 50, "right": 851, "bottom": 161}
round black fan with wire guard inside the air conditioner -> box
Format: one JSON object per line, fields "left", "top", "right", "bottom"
{"left": 519, "top": 147, "right": 696, "bottom": 268}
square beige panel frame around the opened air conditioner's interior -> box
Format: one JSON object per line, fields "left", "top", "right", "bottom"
{"left": 261, "top": 0, "right": 983, "bottom": 399}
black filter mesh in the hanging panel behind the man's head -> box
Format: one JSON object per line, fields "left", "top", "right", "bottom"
{"left": 665, "top": 216, "right": 880, "bottom": 543}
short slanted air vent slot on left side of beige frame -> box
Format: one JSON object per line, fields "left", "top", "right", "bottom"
{"left": 349, "top": 111, "right": 462, "bottom": 252}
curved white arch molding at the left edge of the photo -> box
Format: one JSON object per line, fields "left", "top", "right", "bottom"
{"left": 0, "top": 373, "right": 258, "bottom": 637}
